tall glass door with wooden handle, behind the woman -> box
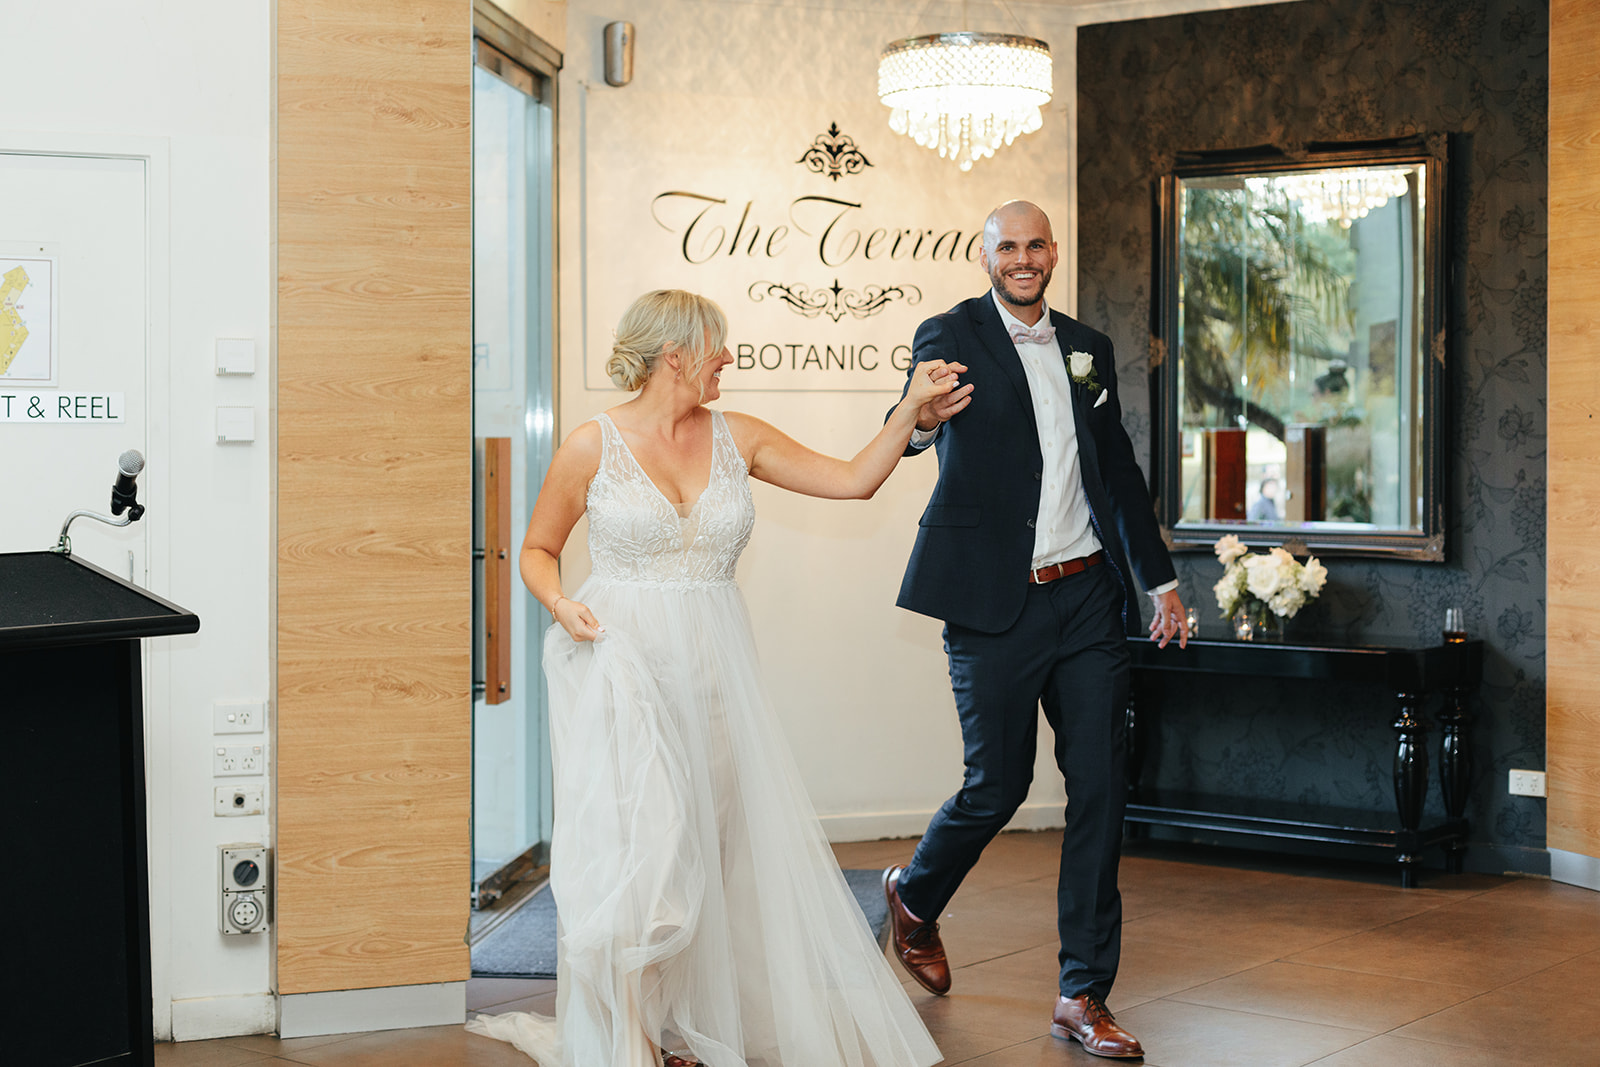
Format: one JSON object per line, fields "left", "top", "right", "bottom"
{"left": 472, "top": 40, "right": 555, "bottom": 907}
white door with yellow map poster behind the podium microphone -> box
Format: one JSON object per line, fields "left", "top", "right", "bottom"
{"left": 0, "top": 150, "right": 149, "bottom": 584}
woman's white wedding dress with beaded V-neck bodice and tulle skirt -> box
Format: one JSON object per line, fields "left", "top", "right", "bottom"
{"left": 467, "top": 413, "right": 939, "bottom": 1067}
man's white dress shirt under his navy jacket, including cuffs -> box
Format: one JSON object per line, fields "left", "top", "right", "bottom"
{"left": 910, "top": 291, "right": 1178, "bottom": 597}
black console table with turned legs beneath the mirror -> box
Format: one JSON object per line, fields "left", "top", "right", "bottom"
{"left": 1126, "top": 637, "right": 1483, "bottom": 886}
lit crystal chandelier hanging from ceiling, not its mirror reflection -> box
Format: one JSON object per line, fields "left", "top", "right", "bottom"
{"left": 878, "top": 32, "right": 1051, "bottom": 171}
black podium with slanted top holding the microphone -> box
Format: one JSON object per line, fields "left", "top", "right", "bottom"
{"left": 0, "top": 552, "right": 200, "bottom": 1067}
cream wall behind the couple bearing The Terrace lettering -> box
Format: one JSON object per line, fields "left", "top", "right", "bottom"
{"left": 558, "top": 0, "right": 1075, "bottom": 840}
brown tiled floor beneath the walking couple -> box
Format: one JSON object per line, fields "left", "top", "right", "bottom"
{"left": 155, "top": 833, "right": 1600, "bottom": 1067}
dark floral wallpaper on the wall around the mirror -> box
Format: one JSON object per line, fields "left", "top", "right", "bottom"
{"left": 1078, "top": 0, "right": 1549, "bottom": 872}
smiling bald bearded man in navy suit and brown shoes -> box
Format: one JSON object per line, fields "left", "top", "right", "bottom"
{"left": 883, "top": 200, "right": 1189, "bottom": 1057}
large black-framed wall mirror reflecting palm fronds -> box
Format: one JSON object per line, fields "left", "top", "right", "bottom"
{"left": 1157, "top": 143, "right": 1442, "bottom": 557}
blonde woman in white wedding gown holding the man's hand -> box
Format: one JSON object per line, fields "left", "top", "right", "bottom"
{"left": 467, "top": 290, "right": 971, "bottom": 1067}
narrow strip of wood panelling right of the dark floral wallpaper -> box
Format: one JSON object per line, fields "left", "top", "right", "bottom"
{"left": 1546, "top": 0, "right": 1600, "bottom": 856}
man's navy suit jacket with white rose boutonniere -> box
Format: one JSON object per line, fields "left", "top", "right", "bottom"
{"left": 896, "top": 293, "right": 1174, "bottom": 633}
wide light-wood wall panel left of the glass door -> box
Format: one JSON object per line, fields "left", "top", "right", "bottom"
{"left": 275, "top": 0, "right": 472, "bottom": 993}
